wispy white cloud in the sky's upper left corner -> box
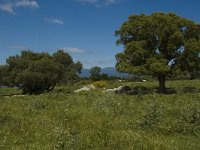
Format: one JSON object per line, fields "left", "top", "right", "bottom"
{"left": 0, "top": 0, "right": 39, "bottom": 14}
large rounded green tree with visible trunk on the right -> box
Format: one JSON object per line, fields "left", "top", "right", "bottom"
{"left": 116, "top": 13, "right": 200, "bottom": 92}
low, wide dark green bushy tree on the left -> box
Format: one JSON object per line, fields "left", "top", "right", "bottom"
{"left": 0, "top": 50, "right": 82, "bottom": 94}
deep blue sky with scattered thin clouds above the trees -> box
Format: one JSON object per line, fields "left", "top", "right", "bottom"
{"left": 0, "top": 0, "right": 200, "bottom": 68}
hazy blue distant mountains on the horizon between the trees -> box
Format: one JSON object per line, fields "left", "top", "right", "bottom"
{"left": 80, "top": 67, "right": 130, "bottom": 78}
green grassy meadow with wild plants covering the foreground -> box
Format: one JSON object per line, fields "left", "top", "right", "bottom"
{"left": 0, "top": 80, "right": 200, "bottom": 150}
